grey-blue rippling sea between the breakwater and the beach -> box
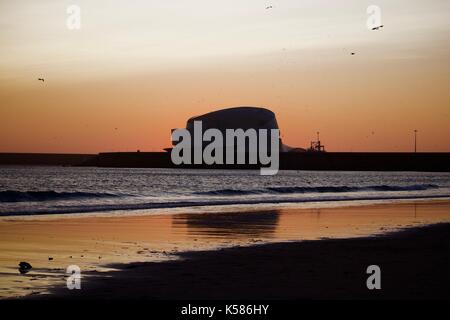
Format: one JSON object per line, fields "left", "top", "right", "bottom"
{"left": 0, "top": 166, "right": 450, "bottom": 216}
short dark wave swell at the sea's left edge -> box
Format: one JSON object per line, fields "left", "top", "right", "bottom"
{"left": 0, "top": 190, "right": 118, "bottom": 202}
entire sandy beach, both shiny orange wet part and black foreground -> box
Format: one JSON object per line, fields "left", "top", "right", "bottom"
{"left": 0, "top": 200, "right": 450, "bottom": 299}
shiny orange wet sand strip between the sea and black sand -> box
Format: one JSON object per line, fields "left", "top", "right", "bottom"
{"left": 0, "top": 201, "right": 450, "bottom": 298}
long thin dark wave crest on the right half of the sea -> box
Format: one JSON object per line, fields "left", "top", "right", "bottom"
{"left": 194, "top": 184, "right": 439, "bottom": 196}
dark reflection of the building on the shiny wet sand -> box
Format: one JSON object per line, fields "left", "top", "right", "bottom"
{"left": 172, "top": 210, "right": 280, "bottom": 239}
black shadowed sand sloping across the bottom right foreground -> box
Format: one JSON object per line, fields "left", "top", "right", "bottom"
{"left": 43, "top": 223, "right": 450, "bottom": 299}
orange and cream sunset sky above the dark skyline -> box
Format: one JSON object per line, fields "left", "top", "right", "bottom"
{"left": 0, "top": 0, "right": 450, "bottom": 153}
